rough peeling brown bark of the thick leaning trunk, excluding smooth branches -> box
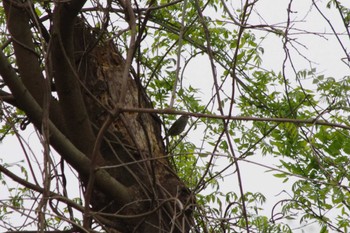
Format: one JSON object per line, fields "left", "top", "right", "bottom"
{"left": 71, "top": 22, "right": 193, "bottom": 232}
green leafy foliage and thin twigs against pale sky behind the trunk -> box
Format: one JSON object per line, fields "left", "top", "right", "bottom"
{"left": 0, "top": 0, "right": 350, "bottom": 232}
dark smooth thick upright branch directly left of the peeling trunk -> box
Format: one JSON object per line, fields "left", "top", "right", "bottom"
{"left": 51, "top": 1, "right": 95, "bottom": 156}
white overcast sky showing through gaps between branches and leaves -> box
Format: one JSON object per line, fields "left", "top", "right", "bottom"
{"left": 0, "top": 0, "right": 350, "bottom": 232}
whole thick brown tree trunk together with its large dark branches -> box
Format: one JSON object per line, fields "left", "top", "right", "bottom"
{"left": 0, "top": 0, "right": 194, "bottom": 233}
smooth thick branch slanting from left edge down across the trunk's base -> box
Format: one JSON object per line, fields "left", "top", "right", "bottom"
{"left": 0, "top": 48, "right": 130, "bottom": 204}
